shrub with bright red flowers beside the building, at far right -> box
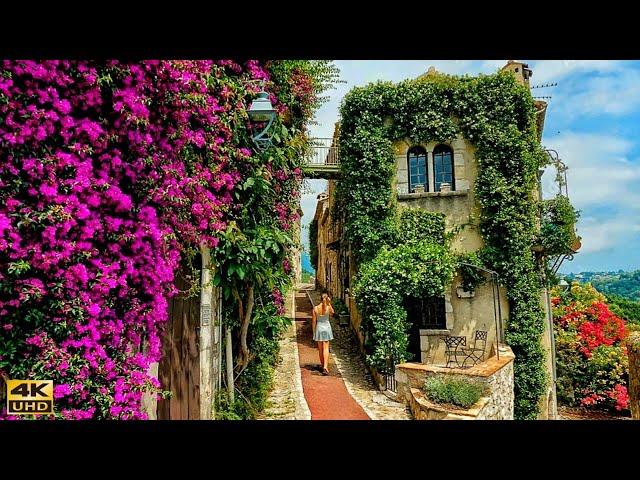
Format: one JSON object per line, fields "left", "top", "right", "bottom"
{"left": 552, "top": 283, "right": 629, "bottom": 411}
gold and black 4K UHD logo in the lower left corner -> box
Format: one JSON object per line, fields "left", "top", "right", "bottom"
{"left": 7, "top": 380, "right": 53, "bottom": 415}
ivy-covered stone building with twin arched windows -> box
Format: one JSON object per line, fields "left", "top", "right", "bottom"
{"left": 314, "top": 61, "right": 576, "bottom": 418}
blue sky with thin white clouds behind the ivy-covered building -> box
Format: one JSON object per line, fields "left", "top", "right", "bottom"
{"left": 302, "top": 59, "right": 640, "bottom": 273}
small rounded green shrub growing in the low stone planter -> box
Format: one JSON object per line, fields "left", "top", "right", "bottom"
{"left": 424, "top": 375, "right": 487, "bottom": 408}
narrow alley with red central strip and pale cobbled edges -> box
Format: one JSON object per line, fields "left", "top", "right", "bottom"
{"left": 260, "top": 285, "right": 410, "bottom": 420}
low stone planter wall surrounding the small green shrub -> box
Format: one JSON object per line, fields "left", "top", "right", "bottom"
{"left": 396, "top": 347, "right": 515, "bottom": 420}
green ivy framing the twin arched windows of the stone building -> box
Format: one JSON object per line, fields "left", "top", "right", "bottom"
{"left": 338, "top": 72, "right": 547, "bottom": 419}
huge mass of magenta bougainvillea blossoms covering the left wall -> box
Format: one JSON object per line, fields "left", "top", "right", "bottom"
{"left": 0, "top": 60, "right": 320, "bottom": 419}
